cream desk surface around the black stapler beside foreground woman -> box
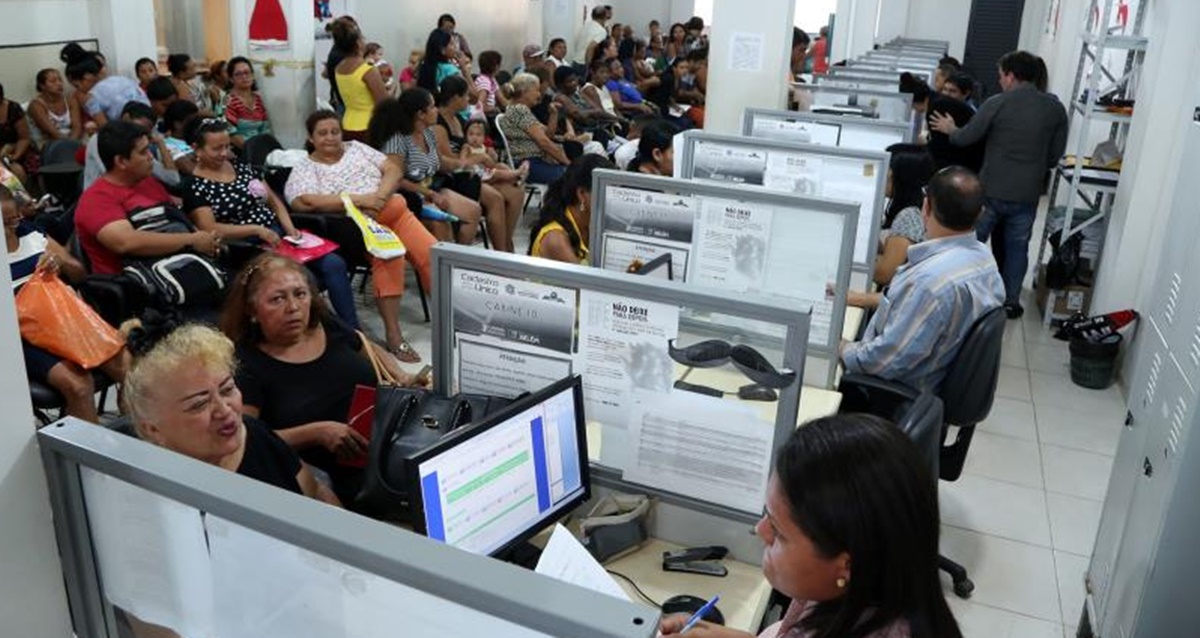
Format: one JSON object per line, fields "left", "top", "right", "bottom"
{"left": 605, "top": 538, "right": 770, "bottom": 633}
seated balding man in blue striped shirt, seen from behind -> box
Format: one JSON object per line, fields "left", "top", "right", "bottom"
{"left": 841, "top": 167, "right": 1004, "bottom": 392}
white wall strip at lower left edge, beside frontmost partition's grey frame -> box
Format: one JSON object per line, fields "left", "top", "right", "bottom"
{"left": 0, "top": 254, "right": 71, "bottom": 638}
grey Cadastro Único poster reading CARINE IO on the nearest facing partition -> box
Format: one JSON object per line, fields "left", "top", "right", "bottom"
{"left": 451, "top": 269, "right": 576, "bottom": 354}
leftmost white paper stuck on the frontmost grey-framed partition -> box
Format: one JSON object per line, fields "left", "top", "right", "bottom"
{"left": 80, "top": 468, "right": 218, "bottom": 638}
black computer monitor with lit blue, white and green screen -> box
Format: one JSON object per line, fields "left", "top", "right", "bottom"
{"left": 408, "top": 375, "right": 590, "bottom": 556}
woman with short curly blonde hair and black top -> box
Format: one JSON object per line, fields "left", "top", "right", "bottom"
{"left": 125, "top": 315, "right": 341, "bottom": 505}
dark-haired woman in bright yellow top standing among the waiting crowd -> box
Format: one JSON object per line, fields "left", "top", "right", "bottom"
{"left": 332, "top": 20, "right": 388, "bottom": 142}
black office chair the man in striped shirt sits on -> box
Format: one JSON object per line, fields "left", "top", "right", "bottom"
{"left": 838, "top": 308, "right": 1007, "bottom": 598}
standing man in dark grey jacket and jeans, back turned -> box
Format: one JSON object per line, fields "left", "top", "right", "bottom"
{"left": 929, "top": 50, "right": 1067, "bottom": 319}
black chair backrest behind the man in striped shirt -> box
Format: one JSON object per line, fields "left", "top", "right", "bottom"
{"left": 940, "top": 307, "right": 1007, "bottom": 426}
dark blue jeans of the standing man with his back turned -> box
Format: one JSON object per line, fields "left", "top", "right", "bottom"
{"left": 976, "top": 199, "right": 1038, "bottom": 306}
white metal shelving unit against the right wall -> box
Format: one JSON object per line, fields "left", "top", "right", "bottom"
{"left": 1036, "top": 0, "right": 1150, "bottom": 325}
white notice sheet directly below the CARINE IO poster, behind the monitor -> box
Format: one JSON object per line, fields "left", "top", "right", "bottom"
{"left": 455, "top": 332, "right": 571, "bottom": 398}
